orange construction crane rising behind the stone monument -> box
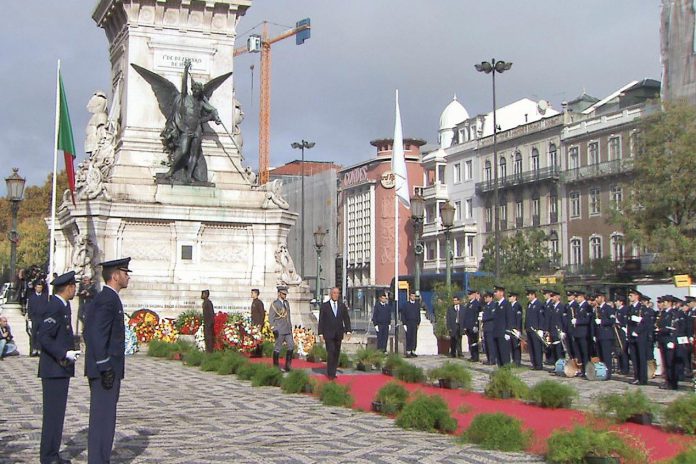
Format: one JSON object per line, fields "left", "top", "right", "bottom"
{"left": 234, "top": 18, "right": 311, "bottom": 185}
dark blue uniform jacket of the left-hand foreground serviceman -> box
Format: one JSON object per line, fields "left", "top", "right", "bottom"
{"left": 37, "top": 295, "right": 75, "bottom": 379}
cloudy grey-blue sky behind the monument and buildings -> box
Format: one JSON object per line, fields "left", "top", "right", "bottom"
{"left": 0, "top": 0, "right": 660, "bottom": 194}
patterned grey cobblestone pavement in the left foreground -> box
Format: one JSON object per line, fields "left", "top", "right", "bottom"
{"left": 0, "top": 354, "right": 540, "bottom": 464}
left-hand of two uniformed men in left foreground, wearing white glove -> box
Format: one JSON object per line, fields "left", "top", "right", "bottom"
{"left": 37, "top": 271, "right": 80, "bottom": 464}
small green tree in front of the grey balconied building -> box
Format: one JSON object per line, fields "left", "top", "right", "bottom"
{"left": 479, "top": 229, "right": 560, "bottom": 277}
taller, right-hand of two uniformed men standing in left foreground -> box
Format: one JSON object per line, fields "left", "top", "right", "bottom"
{"left": 84, "top": 258, "right": 131, "bottom": 464}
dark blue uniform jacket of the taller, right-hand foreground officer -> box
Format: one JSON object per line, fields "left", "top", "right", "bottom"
{"left": 84, "top": 286, "right": 126, "bottom": 379}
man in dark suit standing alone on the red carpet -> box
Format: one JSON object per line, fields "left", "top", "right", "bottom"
{"left": 317, "top": 287, "right": 351, "bottom": 380}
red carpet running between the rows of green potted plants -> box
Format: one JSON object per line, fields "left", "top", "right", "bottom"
{"left": 306, "top": 363, "right": 692, "bottom": 462}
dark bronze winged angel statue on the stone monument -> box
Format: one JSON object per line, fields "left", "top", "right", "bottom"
{"left": 131, "top": 60, "right": 232, "bottom": 185}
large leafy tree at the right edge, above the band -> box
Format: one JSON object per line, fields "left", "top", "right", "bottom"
{"left": 611, "top": 102, "right": 696, "bottom": 274}
